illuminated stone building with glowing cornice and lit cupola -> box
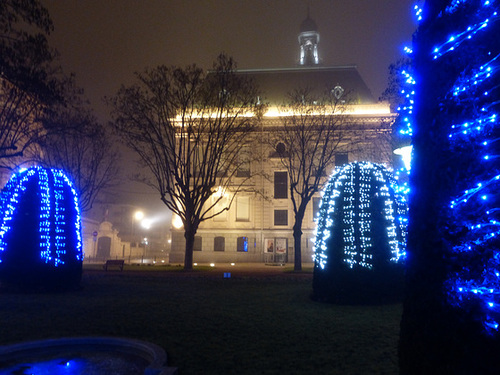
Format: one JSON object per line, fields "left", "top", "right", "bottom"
{"left": 170, "top": 16, "right": 395, "bottom": 263}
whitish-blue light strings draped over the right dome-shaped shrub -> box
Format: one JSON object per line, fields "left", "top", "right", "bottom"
{"left": 313, "top": 162, "right": 407, "bottom": 270}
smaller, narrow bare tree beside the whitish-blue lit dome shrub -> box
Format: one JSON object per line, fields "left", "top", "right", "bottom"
{"left": 269, "top": 89, "right": 350, "bottom": 271}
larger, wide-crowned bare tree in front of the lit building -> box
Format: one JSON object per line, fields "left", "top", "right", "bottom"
{"left": 108, "top": 54, "right": 258, "bottom": 269}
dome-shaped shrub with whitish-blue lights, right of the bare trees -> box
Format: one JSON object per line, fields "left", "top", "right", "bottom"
{"left": 313, "top": 162, "right": 407, "bottom": 303}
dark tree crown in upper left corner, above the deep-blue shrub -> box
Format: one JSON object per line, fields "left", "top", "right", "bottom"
{"left": 0, "top": 0, "right": 60, "bottom": 168}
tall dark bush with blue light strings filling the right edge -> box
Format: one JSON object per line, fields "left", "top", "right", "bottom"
{"left": 398, "top": 0, "right": 500, "bottom": 375}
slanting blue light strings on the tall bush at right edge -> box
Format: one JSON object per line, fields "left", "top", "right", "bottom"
{"left": 429, "top": 0, "right": 500, "bottom": 333}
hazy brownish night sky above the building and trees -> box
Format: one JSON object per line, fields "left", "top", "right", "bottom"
{"left": 42, "top": 0, "right": 416, "bottom": 214}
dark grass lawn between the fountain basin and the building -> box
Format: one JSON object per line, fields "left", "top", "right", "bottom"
{"left": 0, "top": 267, "right": 402, "bottom": 375}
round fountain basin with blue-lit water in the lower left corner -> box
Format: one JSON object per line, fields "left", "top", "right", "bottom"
{"left": 0, "top": 337, "right": 177, "bottom": 375}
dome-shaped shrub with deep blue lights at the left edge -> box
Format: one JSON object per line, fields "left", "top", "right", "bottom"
{"left": 0, "top": 167, "right": 83, "bottom": 289}
